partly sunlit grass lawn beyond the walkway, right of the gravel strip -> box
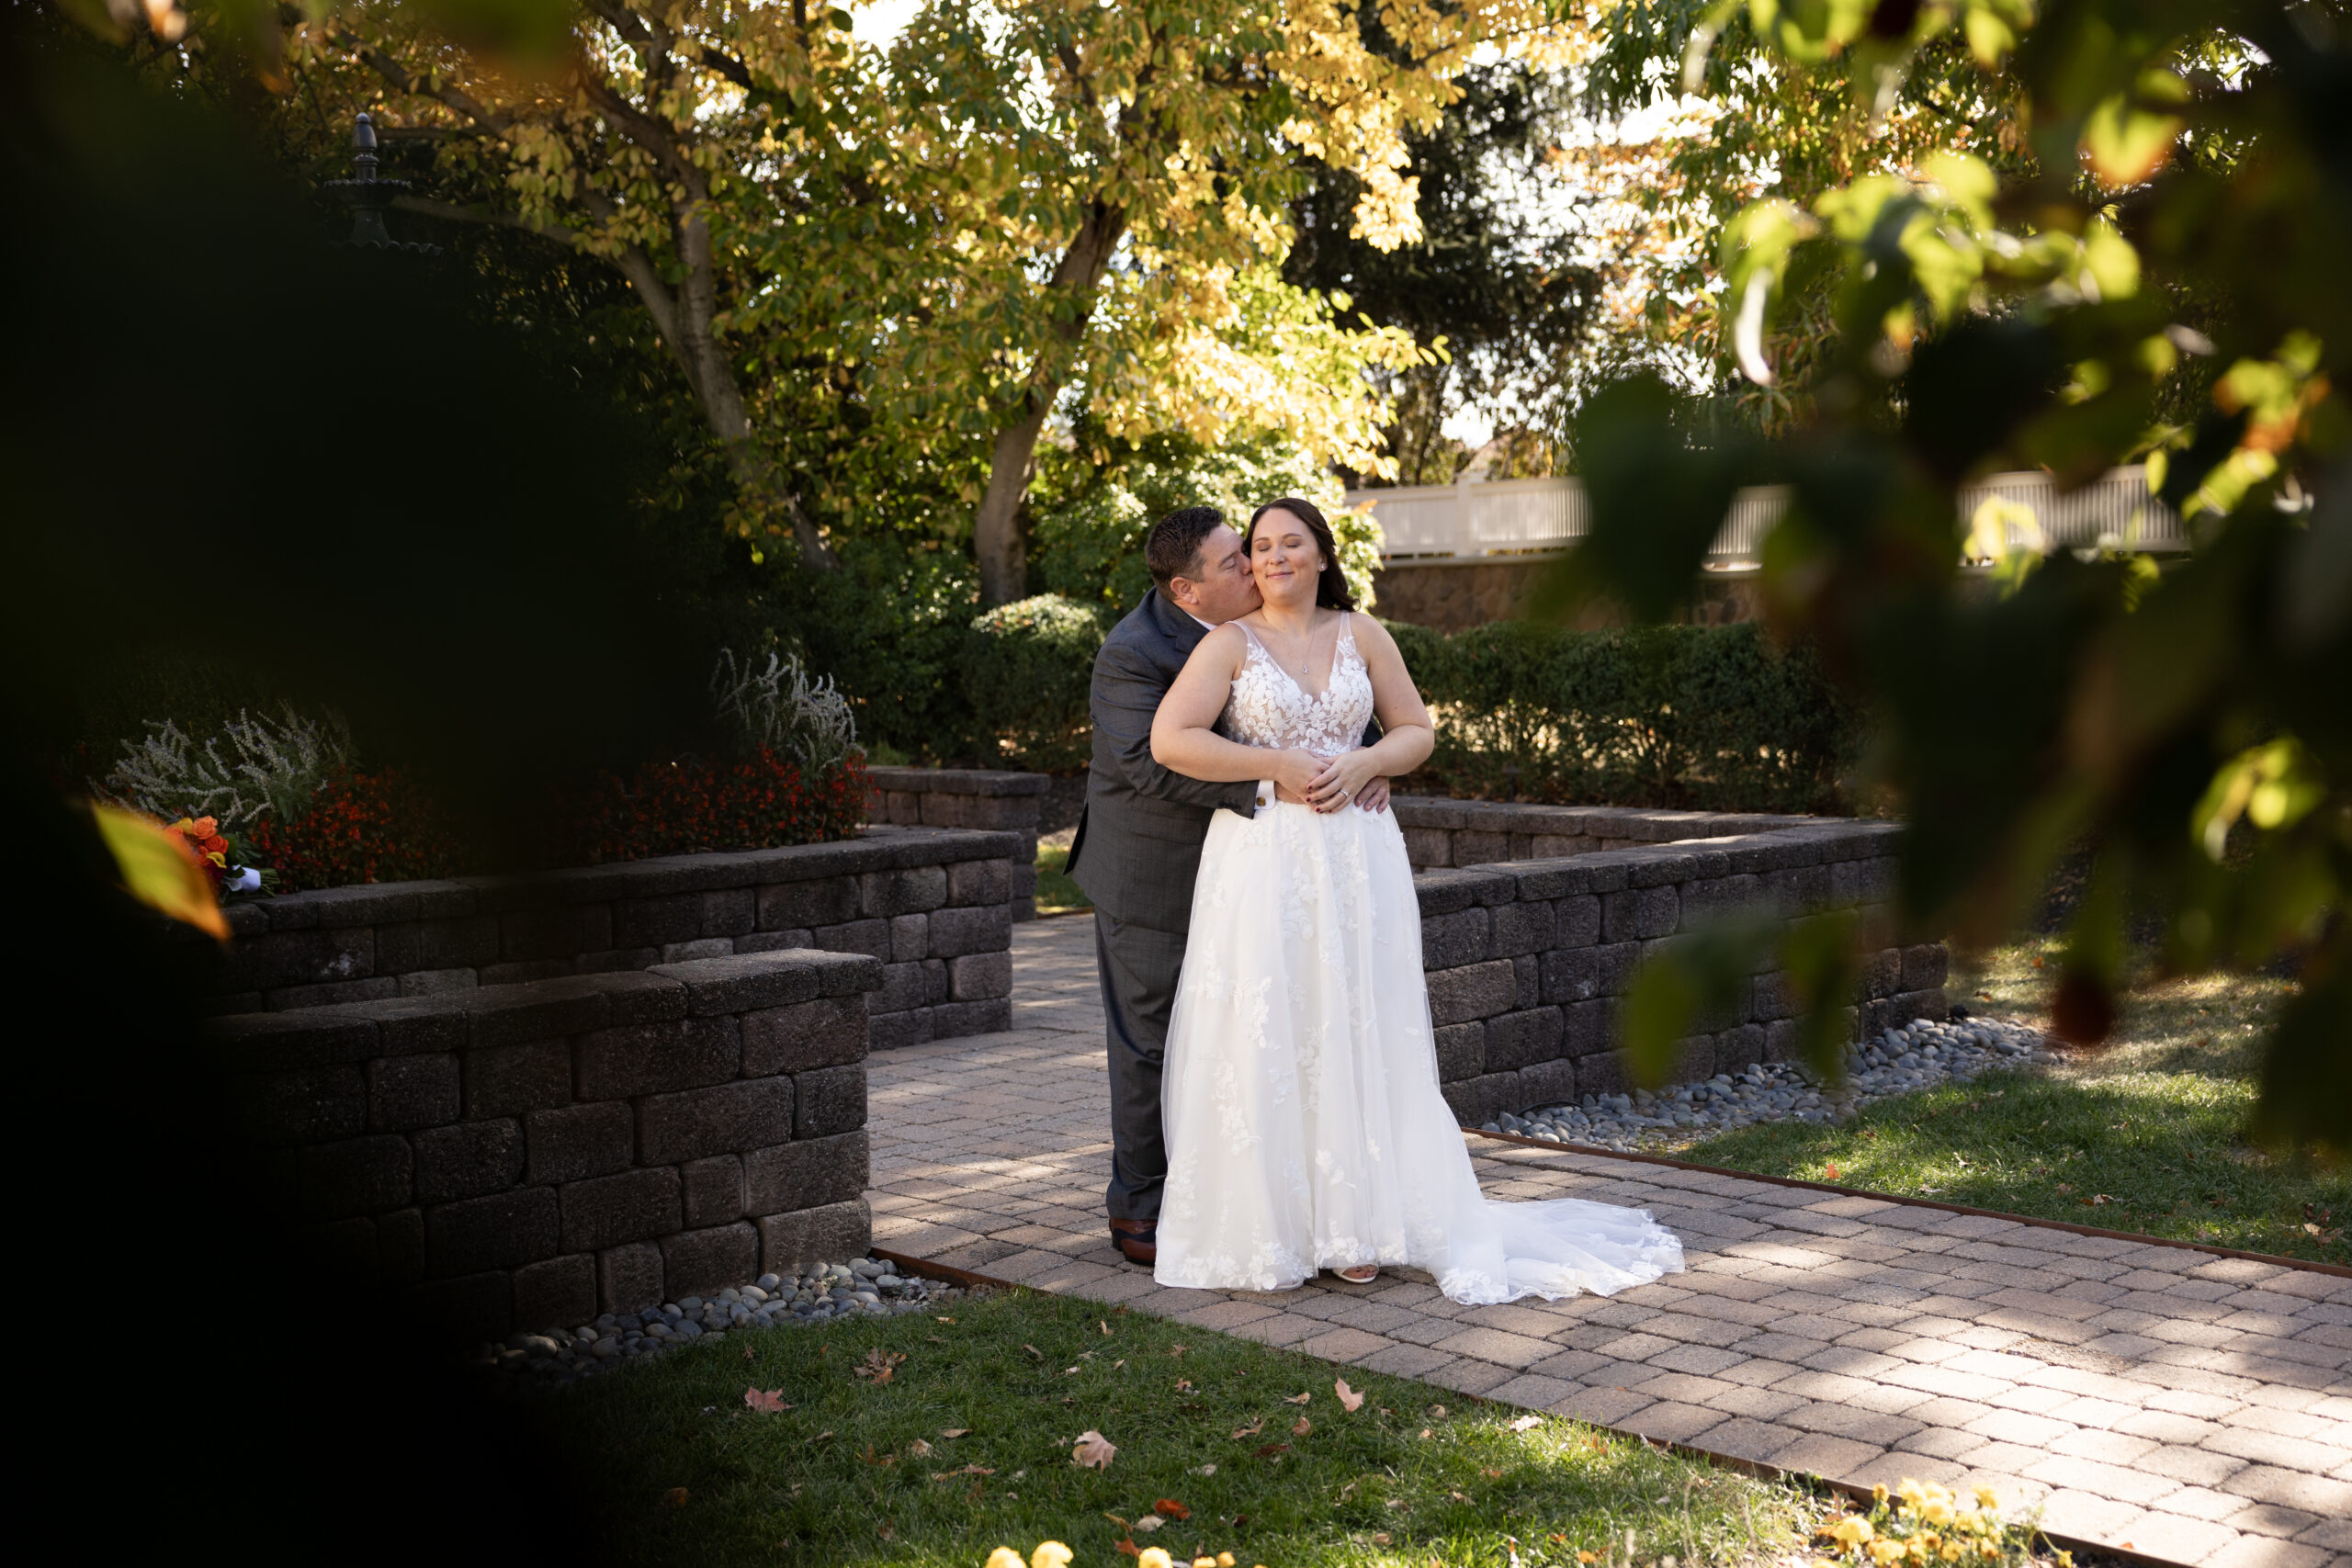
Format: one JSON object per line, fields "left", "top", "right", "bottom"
{"left": 1681, "top": 942, "right": 2352, "bottom": 1262}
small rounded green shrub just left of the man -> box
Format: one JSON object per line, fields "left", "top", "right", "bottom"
{"left": 965, "top": 592, "right": 1103, "bottom": 773}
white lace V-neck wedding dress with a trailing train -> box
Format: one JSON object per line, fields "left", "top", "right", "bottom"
{"left": 1155, "top": 618, "right": 1681, "bottom": 1303}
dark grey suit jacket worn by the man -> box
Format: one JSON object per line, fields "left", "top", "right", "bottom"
{"left": 1070, "top": 588, "right": 1259, "bottom": 931}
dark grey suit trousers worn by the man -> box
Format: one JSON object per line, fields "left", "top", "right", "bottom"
{"left": 1093, "top": 909, "right": 1185, "bottom": 1220}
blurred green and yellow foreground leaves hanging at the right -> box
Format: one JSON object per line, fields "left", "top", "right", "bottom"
{"left": 1555, "top": 0, "right": 2352, "bottom": 1155}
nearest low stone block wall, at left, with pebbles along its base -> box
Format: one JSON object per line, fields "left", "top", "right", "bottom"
{"left": 207, "top": 950, "right": 882, "bottom": 1340}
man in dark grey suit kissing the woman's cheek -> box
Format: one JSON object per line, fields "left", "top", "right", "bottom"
{"left": 1070, "top": 505, "right": 1387, "bottom": 1265}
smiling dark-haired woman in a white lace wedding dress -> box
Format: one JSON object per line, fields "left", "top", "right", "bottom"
{"left": 1152, "top": 499, "right": 1681, "bottom": 1303}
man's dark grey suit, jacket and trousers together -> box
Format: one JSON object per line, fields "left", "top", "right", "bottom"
{"left": 1070, "top": 588, "right": 1259, "bottom": 1220}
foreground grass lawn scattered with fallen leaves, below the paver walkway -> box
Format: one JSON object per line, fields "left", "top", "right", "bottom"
{"left": 541, "top": 1293, "right": 1827, "bottom": 1568}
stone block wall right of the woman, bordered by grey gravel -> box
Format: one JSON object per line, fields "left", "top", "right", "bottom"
{"left": 1414, "top": 823, "right": 1945, "bottom": 1126}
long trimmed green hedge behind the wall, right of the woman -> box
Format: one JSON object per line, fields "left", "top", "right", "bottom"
{"left": 1390, "top": 621, "right": 1860, "bottom": 811}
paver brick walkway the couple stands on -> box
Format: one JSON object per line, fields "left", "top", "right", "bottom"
{"left": 868, "top": 917, "right": 2352, "bottom": 1568}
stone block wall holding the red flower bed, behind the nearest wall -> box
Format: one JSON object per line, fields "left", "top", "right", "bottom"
{"left": 190, "top": 828, "right": 1035, "bottom": 1046}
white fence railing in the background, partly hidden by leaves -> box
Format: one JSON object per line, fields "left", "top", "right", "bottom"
{"left": 1348, "top": 466, "right": 2189, "bottom": 562}
